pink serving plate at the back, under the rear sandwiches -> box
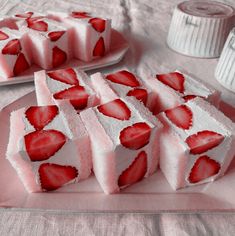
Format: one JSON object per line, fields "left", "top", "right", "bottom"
{"left": 0, "top": 29, "right": 129, "bottom": 86}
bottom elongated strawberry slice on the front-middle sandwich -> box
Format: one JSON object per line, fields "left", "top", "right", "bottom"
{"left": 118, "top": 151, "right": 147, "bottom": 187}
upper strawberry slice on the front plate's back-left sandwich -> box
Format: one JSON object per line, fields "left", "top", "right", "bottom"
{"left": 47, "top": 68, "right": 79, "bottom": 85}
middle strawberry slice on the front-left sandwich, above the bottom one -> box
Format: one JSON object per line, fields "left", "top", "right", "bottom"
{"left": 24, "top": 129, "right": 66, "bottom": 161}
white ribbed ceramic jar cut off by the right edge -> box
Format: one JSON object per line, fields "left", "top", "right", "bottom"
{"left": 215, "top": 28, "right": 235, "bottom": 92}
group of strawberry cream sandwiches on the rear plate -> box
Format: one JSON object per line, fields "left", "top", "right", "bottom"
{"left": 0, "top": 12, "right": 111, "bottom": 81}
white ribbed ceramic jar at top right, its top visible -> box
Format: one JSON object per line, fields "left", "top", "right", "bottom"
{"left": 167, "top": 0, "right": 235, "bottom": 58}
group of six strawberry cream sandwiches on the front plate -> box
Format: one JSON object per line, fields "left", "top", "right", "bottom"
{"left": 7, "top": 67, "right": 235, "bottom": 194}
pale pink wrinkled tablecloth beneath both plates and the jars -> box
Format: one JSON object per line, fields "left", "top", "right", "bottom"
{"left": 0, "top": 0, "right": 235, "bottom": 236}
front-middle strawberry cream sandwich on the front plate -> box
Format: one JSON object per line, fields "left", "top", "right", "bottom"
{"left": 80, "top": 98, "right": 162, "bottom": 194}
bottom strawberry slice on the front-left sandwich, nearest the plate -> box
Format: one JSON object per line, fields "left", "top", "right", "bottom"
{"left": 38, "top": 163, "right": 78, "bottom": 191}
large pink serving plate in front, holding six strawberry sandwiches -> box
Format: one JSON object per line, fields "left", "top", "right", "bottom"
{"left": 0, "top": 92, "right": 235, "bottom": 213}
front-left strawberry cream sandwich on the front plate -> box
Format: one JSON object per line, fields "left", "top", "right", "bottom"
{"left": 7, "top": 102, "right": 91, "bottom": 192}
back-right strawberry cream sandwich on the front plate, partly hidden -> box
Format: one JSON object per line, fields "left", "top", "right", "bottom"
{"left": 145, "top": 71, "right": 220, "bottom": 114}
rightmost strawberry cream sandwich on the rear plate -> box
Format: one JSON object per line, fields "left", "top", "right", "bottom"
{"left": 48, "top": 11, "right": 111, "bottom": 62}
